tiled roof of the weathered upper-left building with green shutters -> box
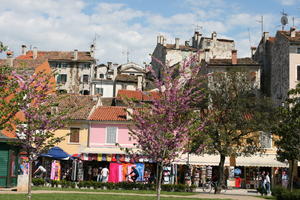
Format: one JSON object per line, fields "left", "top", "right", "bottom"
{"left": 16, "top": 51, "right": 94, "bottom": 61}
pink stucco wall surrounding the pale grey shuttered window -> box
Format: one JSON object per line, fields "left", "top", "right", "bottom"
{"left": 90, "top": 124, "right": 134, "bottom": 147}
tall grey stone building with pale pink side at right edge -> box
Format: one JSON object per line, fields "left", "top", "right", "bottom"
{"left": 253, "top": 27, "right": 300, "bottom": 106}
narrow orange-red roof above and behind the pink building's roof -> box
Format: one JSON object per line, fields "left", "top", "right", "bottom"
{"left": 117, "top": 90, "right": 159, "bottom": 101}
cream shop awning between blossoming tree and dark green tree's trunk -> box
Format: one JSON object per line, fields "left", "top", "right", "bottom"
{"left": 173, "top": 154, "right": 229, "bottom": 166}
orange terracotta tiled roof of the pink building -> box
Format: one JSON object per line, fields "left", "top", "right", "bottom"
{"left": 89, "top": 106, "right": 127, "bottom": 121}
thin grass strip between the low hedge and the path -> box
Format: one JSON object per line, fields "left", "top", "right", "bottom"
{"left": 32, "top": 187, "right": 195, "bottom": 196}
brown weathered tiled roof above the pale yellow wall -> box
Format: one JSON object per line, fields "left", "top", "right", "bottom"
{"left": 58, "top": 94, "right": 99, "bottom": 120}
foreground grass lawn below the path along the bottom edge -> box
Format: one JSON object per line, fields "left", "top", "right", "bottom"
{"left": 0, "top": 193, "right": 223, "bottom": 200}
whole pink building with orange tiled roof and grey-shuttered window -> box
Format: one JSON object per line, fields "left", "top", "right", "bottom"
{"left": 82, "top": 106, "right": 134, "bottom": 154}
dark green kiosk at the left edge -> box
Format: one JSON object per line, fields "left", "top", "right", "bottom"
{"left": 0, "top": 131, "right": 19, "bottom": 188}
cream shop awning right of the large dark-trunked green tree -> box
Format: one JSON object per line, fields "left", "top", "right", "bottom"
{"left": 236, "top": 154, "right": 288, "bottom": 167}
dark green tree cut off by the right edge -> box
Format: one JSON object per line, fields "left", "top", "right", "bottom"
{"left": 273, "top": 84, "right": 300, "bottom": 191}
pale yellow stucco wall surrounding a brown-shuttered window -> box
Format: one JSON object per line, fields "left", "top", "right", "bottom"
{"left": 55, "top": 121, "right": 89, "bottom": 155}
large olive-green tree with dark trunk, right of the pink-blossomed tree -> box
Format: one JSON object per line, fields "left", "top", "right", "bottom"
{"left": 191, "top": 70, "right": 273, "bottom": 193}
